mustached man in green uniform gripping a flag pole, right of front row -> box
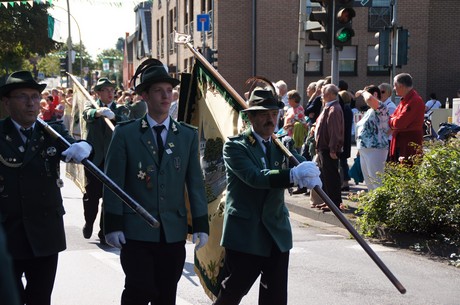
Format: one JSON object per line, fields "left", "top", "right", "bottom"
{"left": 214, "top": 83, "right": 321, "bottom": 305}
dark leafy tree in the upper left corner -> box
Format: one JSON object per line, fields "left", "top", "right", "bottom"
{"left": 0, "top": 3, "right": 61, "bottom": 74}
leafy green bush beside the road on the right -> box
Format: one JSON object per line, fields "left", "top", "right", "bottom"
{"left": 357, "top": 139, "right": 460, "bottom": 245}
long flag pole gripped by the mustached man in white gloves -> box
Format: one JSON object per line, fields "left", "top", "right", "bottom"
{"left": 174, "top": 33, "right": 406, "bottom": 294}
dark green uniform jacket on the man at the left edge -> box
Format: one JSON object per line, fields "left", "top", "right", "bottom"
{"left": 0, "top": 118, "right": 75, "bottom": 259}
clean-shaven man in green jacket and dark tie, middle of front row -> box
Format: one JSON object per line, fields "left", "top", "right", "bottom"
{"left": 103, "top": 60, "right": 209, "bottom": 305}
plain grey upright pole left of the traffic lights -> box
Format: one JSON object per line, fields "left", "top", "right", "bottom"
{"left": 296, "top": 0, "right": 307, "bottom": 101}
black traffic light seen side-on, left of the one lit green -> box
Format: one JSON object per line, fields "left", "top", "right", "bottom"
{"left": 308, "top": 0, "right": 333, "bottom": 50}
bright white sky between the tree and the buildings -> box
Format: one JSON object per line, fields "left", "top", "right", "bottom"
{"left": 48, "top": 0, "right": 141, "bottom": 59}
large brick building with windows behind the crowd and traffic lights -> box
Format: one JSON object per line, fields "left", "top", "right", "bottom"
{"left": 124, "top": 0, "right": 460, "bottom": 101}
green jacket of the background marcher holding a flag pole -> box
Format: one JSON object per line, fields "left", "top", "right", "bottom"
{"left": 83, "top": 100, "right": 129, "bottom": 166}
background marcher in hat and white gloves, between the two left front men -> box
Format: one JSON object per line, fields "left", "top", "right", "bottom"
{"left": 82, "top": 78, "right": 129, "bottom": 244}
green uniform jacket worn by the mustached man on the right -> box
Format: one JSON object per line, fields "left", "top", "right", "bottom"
{"left": 221, "top": 130, "right": 303, "bottom": 257}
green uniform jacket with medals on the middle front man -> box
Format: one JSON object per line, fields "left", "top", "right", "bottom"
{"left": 103, "top": 117, "right": 209, "bottom": 243}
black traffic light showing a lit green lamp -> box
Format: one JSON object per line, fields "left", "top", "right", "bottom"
{"left": 334, "top": 0, "right": 356, "bottom": 48}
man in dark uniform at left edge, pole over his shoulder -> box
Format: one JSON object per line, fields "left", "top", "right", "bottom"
{"left": 0, "top": 71, "right": 91, "bottom": 305}
